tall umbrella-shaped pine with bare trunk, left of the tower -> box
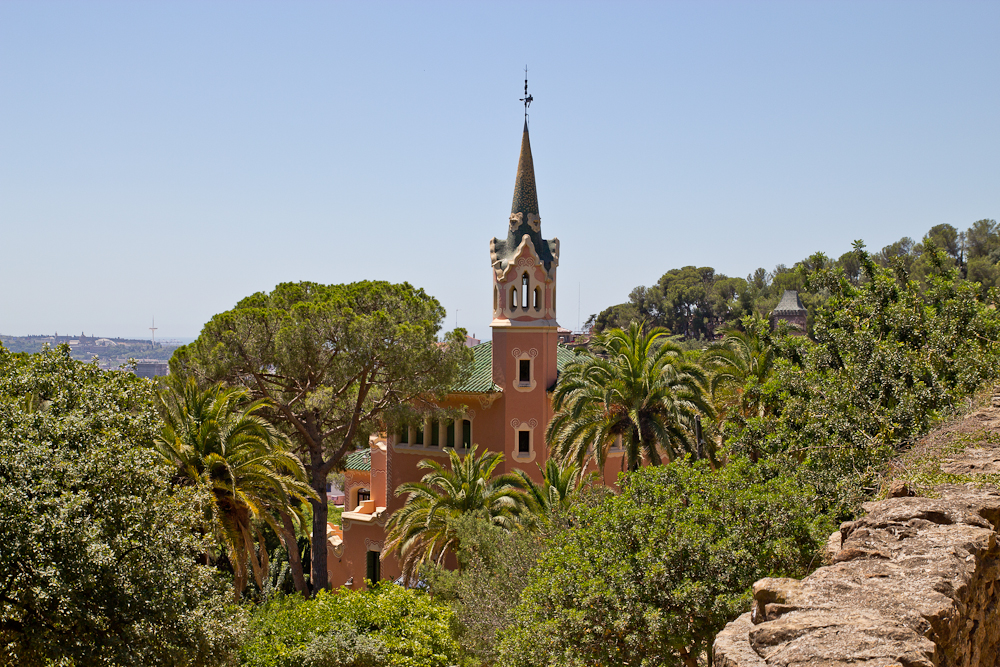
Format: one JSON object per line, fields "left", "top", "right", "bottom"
{"left": 170, "top": 281, "right": 469, "bottom": 589}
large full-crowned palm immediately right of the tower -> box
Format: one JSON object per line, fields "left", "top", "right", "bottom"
{"left": 545, "top": 322, "right": 711, "bottom": 470}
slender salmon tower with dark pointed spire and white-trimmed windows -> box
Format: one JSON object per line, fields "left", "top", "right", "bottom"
{"left": 490, "top": 121, "right": 559, "bottom": 472}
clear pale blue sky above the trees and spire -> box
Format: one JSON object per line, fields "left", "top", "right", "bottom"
{"left": 0, "top": 0, "right": 1000, "bottom": 337}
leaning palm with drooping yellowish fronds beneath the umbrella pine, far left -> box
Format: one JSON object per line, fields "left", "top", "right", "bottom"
{"left": 153, "top": 378, "right": 316, "bottom": 600}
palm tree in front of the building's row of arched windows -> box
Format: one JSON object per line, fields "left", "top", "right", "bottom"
{"left": 386, "top": 446, "right": 528, "bottom": 581}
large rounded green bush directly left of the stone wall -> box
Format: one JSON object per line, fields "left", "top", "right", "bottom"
{"left": 502, "top": 459, "right": 829, "bottom": 667}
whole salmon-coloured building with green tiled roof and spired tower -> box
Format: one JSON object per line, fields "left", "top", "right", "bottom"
{"left": 327, "top": 123, "right": 621, "bottom": 588}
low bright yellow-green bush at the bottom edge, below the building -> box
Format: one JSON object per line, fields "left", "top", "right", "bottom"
{"left": 241, "top": 583, "right": 460, "bottom": 667}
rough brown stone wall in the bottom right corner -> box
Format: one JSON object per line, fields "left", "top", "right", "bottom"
{"left": 714, "top": 484, "right": 1000, "bottom": 667}
